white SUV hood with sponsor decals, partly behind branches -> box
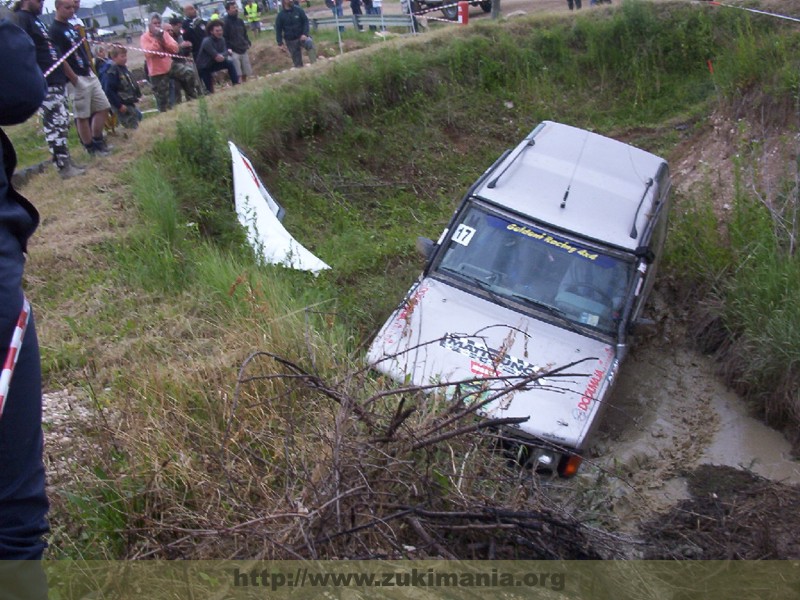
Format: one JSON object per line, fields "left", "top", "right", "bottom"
{"left": 368, "top": 278, "right": 616, "bottom": 449}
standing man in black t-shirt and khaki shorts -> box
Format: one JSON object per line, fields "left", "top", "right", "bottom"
{"left": 50, "top": 0, "right": 110, "bottom": 155}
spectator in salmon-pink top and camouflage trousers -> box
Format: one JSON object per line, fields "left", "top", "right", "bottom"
{"left": 139, "top": 13, "right": 198, "bottom": 112}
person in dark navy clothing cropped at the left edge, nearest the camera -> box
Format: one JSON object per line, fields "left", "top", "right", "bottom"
{"left": 0, "top": 19, "right": 49, "bottom": 600}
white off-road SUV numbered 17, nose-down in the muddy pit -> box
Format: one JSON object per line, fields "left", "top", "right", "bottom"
{"left": 368, "top": 122, "right": 670, "bottom": 476}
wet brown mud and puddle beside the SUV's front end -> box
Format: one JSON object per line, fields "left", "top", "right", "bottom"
{"left": 547, "top": 344, "right": 800, "bottom": 557}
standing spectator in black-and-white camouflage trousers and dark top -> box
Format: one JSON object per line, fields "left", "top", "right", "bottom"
{"left": 15, "top": 0, "right": 85, "bottom": 179}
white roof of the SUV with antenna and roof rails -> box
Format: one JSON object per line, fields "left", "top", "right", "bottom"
{"left": 473, "top": 121, "right": 666, "bottom": 250}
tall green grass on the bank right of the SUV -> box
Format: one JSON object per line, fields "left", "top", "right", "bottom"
{"left": 667, "top": 159, "right": 800, "bottom": 442}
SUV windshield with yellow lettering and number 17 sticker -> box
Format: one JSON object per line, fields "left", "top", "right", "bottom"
{"left": 434, "top": 204, "right": 634, "bottom": 335}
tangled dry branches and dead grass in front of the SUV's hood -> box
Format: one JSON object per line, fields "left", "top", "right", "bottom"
{"left": 122, "top": 352, "right": 616, "bottom": 559}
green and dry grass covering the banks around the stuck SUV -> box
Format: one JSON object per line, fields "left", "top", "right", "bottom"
{"left": 14, "top": 3, "right": 800, "bottom": 557}
